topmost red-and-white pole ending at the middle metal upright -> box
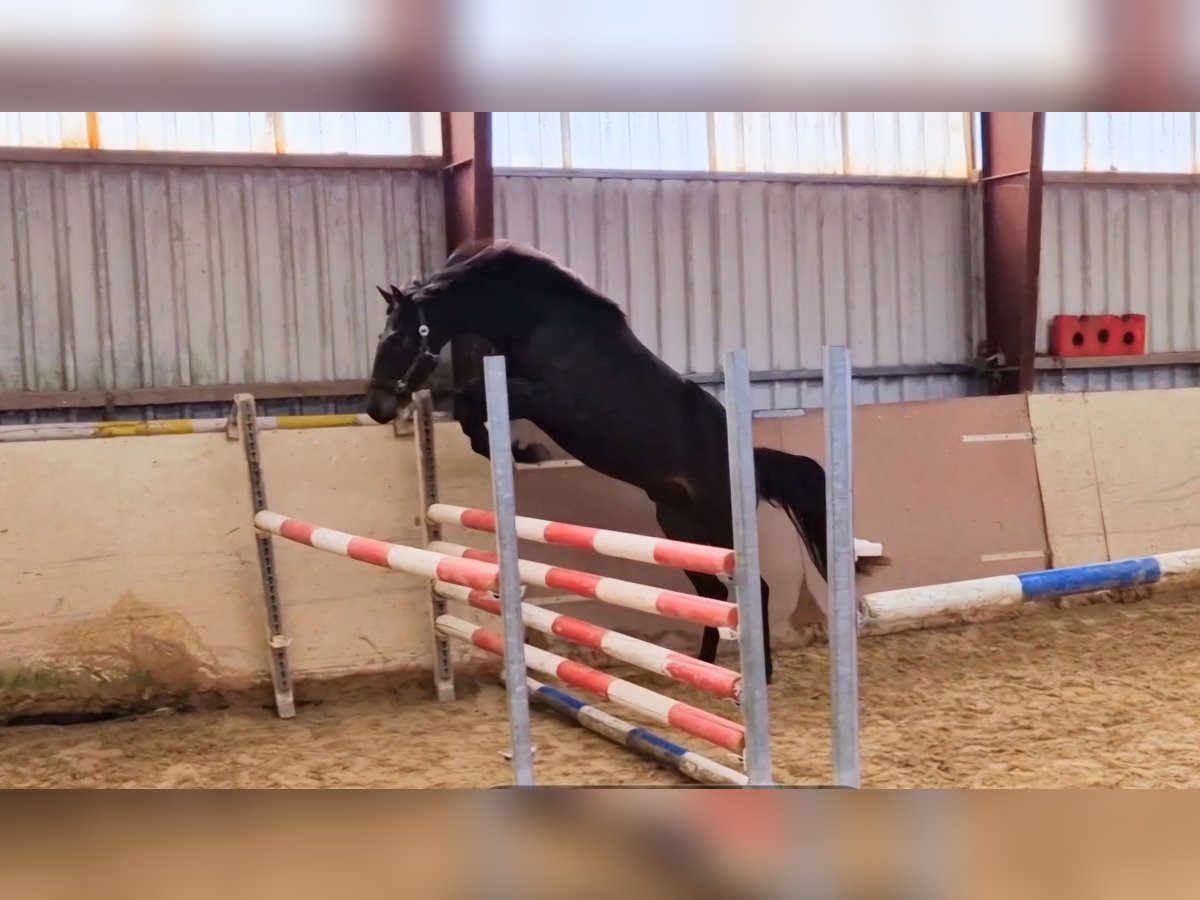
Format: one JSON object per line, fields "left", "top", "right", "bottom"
{"left": 428, "top": 503, "right": 737, "bottom": 575}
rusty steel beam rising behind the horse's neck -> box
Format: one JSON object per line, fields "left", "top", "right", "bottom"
{"left": 442, "top": 113, "right": 496, "bottom": 388}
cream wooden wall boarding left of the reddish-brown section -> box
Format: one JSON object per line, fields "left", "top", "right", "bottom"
{"left": 0, "top": 424, "right": 491, "bottom": 710}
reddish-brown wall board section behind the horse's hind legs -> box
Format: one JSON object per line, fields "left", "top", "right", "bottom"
{"left": 518, "top": 397, "right": 1048, "bottom": 648}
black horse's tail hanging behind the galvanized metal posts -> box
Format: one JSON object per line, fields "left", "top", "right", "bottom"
{"left": 754, "top": 446, "right": 890, "bottom": 578}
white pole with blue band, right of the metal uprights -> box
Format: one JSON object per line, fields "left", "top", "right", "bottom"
{"left": 862, "top": 550, "right": 1200, "bottom": 623}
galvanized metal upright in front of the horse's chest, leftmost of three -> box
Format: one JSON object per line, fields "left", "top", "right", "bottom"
{"left": 484, "top": 356, "right": 534, "bottom": 787}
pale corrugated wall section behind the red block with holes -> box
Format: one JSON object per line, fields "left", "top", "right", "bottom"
{"left": 1037, "top": 184, "right": 1200, "bottom": 353}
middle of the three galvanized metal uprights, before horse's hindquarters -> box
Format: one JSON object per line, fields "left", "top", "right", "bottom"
{"left": 725, "top": 349, "right": 775, "bottom": 787}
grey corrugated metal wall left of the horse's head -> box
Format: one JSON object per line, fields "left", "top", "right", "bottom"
{"left": 0, "top": 163, "right": 445, "bottom": 391}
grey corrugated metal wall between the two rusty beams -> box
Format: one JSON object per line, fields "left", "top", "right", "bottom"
{"left": 496, "top": 175, "right": 972, "bottom": 408}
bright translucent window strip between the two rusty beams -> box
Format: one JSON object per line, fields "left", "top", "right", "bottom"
{"left": 492, "top": 113, "right": 972, "bottom": 178}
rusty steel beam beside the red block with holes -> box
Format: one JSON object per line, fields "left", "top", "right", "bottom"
{"left": 982, "top": 113, "right": 1045, "bottom": 394}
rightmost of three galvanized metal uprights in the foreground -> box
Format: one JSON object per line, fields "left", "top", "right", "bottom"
{"left": 824, "top": 346, "right": 862, "bottom": 787}
